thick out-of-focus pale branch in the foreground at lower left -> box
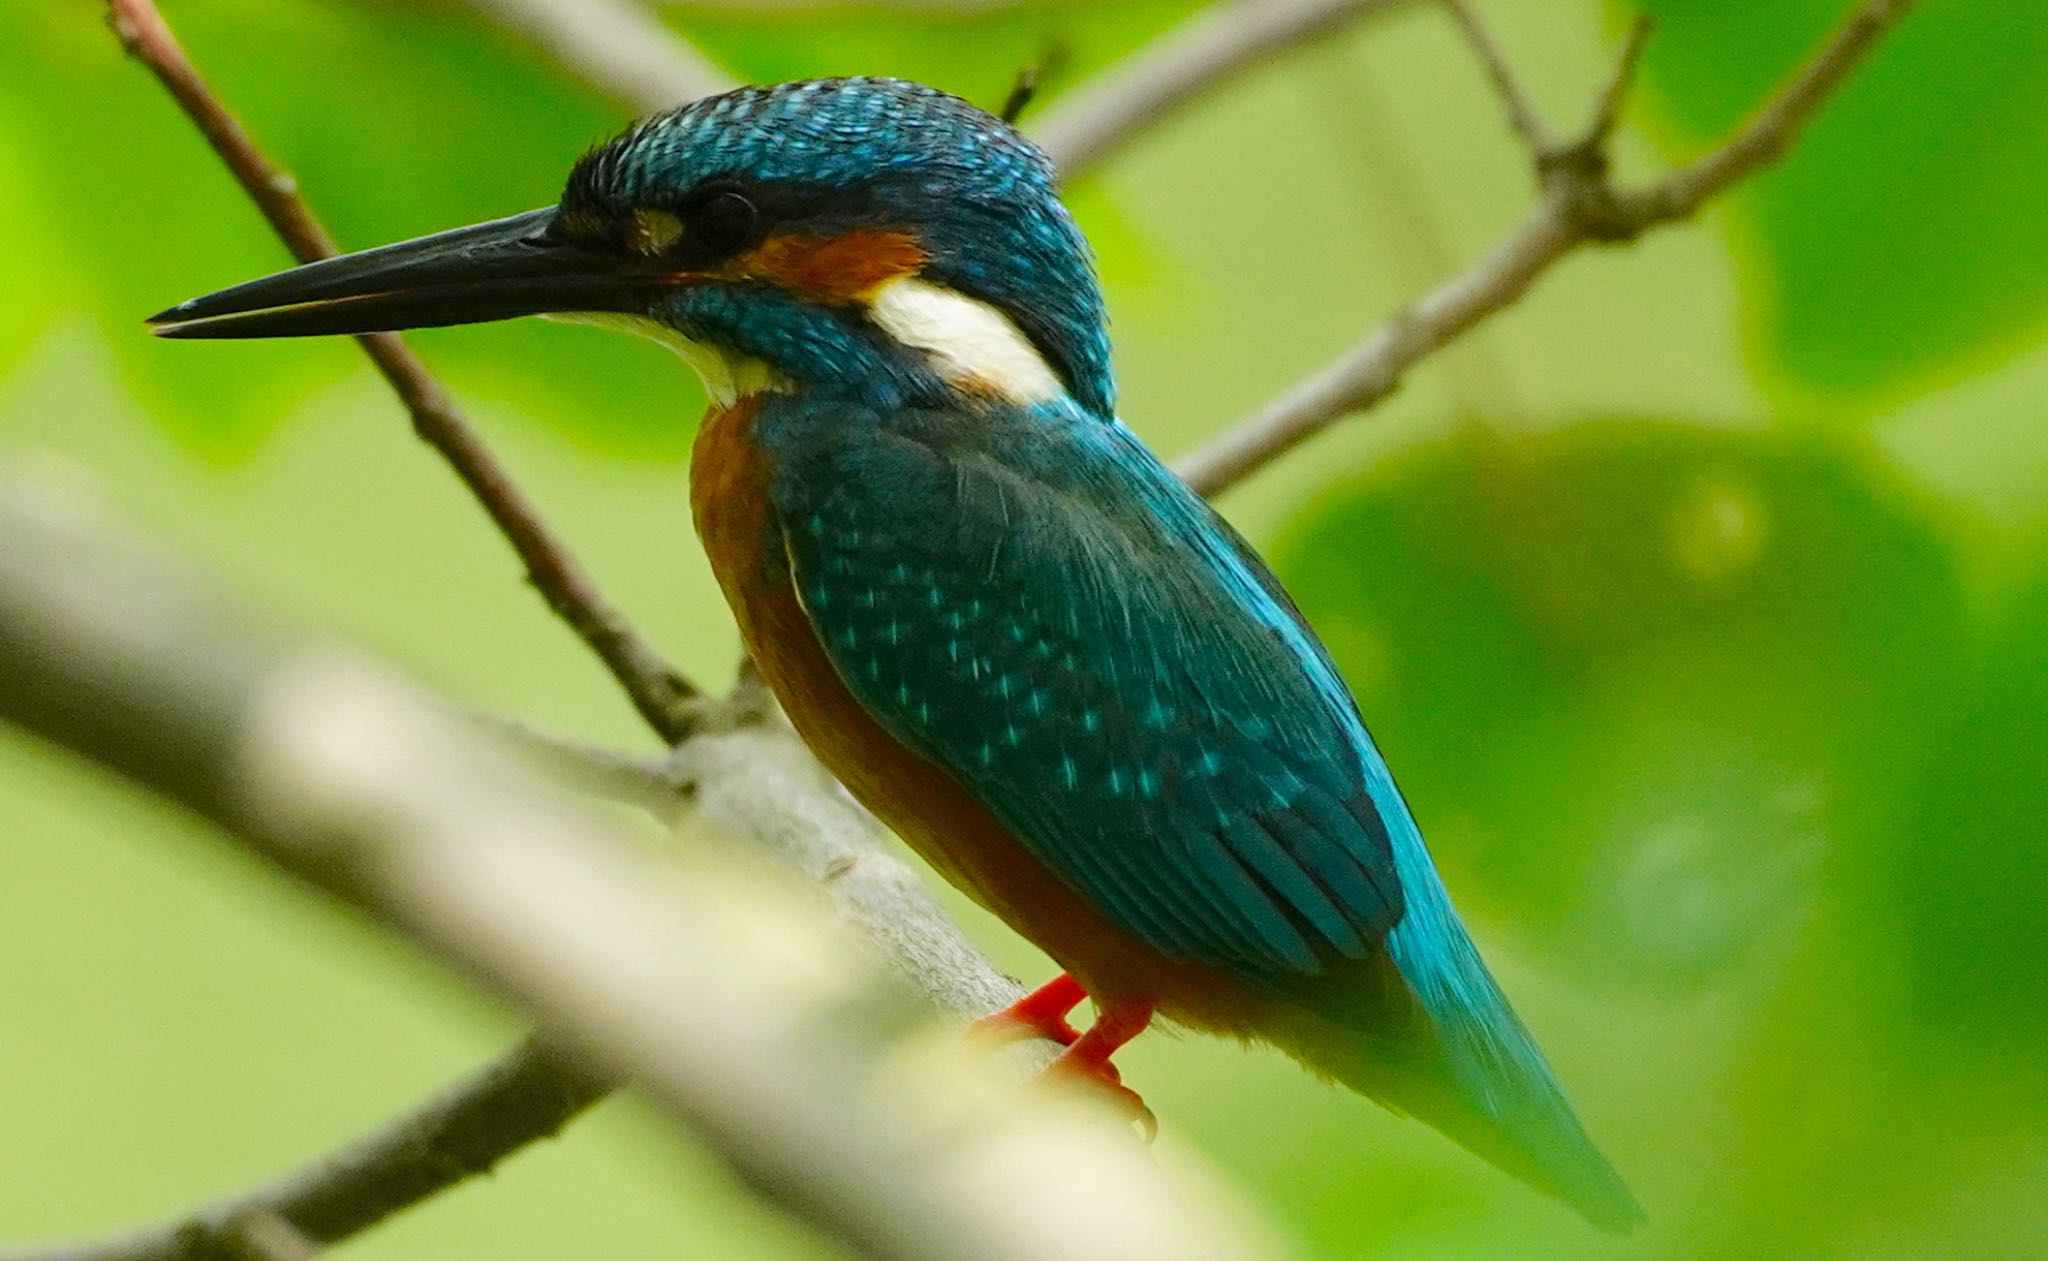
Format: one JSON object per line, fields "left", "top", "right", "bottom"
{"left": 0, "top": 493, "right": 1270, "bottom": 1261}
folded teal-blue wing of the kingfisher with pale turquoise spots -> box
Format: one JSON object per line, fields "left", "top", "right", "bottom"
{"left": 762, "top": 399, "right": 1405, "bottom": 981}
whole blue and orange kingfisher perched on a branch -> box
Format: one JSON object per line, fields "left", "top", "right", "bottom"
{"left": 152, "top": 78, "right": 1640, "bottom": 1230}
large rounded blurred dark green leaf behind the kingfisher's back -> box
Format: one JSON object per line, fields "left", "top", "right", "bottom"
{"left": 1278, "top": 422, "right": 1960, "bottom": 987}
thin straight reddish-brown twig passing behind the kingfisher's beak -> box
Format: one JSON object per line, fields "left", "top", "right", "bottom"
{"left": 109, "top": 0, "right": 696, "bottom": 743}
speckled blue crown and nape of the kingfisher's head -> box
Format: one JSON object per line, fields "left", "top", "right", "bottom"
{"left": 563, "top": 78, "right": 1116, "bottom": 416}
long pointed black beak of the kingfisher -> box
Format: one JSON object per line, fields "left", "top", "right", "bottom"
{"left": 150, "top": 207, "right": 664, "bottom": 338}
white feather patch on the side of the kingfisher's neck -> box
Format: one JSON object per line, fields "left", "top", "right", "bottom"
{"left": 868, "top": 276, "right": 1067, "bottom": 403}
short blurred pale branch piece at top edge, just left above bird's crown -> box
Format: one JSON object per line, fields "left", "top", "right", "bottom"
{"left": 465, "top": 0, "right": 737, "bottom": 115}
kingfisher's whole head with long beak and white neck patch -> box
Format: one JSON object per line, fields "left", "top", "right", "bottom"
{"left": 150, "top": 78, "right": 1114, "bottom": 418}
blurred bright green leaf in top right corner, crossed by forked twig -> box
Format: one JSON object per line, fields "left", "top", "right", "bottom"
{"left": 1642, "top": 0, "right": 2048, "bottom": 407}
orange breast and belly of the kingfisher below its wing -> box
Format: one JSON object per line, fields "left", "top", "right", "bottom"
{"left": 690, "top": 401, "right": 1264, "bottom": 1034}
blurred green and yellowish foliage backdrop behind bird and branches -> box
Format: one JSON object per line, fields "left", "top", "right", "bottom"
{"left": 0, "top": 0, "right": 2048, "bottom": 1261}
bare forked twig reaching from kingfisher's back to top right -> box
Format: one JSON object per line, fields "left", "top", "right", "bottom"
{"left": 1176, "top": 0, "right": 1913, "bottom": 495}
